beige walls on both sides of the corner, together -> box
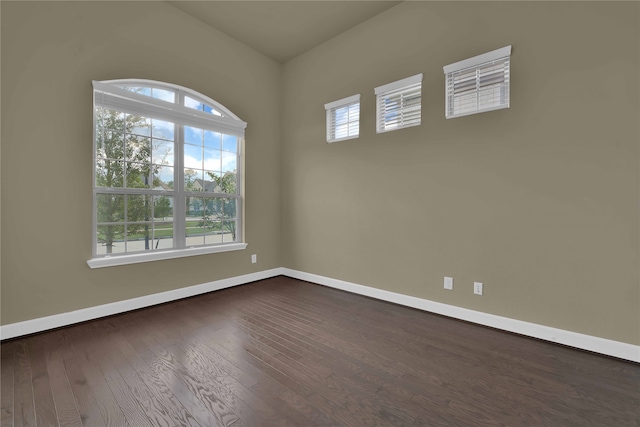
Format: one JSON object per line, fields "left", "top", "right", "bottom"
{"left": 1, "top": 2, "right": 640, "bottom": 344}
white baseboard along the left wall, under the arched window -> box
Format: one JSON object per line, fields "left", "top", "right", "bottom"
{"left": 0, "top": 268, "right": 282, "bottom": 340}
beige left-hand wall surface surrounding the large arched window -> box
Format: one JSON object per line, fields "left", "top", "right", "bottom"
{"left": 2, "top": 2, "right": 282, "bottom": 325}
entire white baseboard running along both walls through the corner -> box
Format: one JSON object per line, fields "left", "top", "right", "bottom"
{"left": 0, "top": 268, "right": 640, "bottom": 363}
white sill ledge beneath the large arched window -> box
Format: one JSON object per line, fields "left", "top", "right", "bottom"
{"left": 87, "top": 243, "right": 247, "bottom": 268}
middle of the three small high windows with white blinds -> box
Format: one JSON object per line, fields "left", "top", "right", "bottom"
{"left": 375, "top": 74, "right": 422, "bottom": 133}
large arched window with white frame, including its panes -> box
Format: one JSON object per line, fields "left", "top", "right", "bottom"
{"left": 88, "top": 80, "right": 247, "bottom": 267}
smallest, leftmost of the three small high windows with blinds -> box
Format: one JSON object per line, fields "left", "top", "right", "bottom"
{"left": 324, "top": 94, "right": 360, "bottom": 142}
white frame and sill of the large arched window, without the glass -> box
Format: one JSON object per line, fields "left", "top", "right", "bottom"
{"left": 87, "top": 79, "right": 247, "bottom": 268}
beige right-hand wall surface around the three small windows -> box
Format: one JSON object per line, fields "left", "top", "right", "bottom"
{"left": 282, "top": 2, "right": 640, "bottom": 344}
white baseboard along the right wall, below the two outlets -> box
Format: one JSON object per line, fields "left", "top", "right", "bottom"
{"left": 282, "top": 268, "right": 640, "bottom": 363}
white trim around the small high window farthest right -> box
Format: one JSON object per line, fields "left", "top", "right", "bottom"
{"left": 442, "top": 45, "right": 511, "bottom": 119}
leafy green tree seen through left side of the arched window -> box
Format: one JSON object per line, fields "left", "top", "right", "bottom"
{"left": 96, "top": 108, "right": 152, "bottom": 253}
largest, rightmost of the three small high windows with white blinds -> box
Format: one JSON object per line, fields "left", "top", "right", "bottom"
{"left": 444, "top": 46, "right": 511, "bottom": 119}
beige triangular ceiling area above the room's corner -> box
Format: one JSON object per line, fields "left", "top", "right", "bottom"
{"left": 169, "top": 0, "right": 400, "bottom": 63}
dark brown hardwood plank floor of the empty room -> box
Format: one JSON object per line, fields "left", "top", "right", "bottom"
{"left": 1, "top": 277, "right": 640, "bottom": 427}
